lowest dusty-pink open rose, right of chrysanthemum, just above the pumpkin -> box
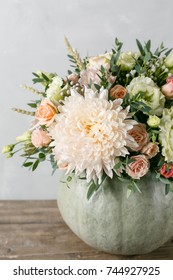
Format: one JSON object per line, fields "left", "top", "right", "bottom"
{"left": 126, "top": 155, "right": 150, "bottom": 179}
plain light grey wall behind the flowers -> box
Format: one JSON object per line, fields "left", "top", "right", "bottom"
{"left": 0, "top": 0, "right": 173, "bottom": 199}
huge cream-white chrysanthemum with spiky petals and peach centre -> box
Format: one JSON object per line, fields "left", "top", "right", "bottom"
{"left": 50, "top": 89, "right": 136, "bottom": 182}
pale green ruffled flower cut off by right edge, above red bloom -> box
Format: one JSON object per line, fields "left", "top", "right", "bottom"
{"left": 159, "top": 107, "right": 173, "bottom": 162}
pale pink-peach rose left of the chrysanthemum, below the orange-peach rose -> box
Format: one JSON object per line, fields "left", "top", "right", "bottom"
{"left": 31, "top": 129, "right": 51, "bottom": 148}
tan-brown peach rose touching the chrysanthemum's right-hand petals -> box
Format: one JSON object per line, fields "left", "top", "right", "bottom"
{"left": 128, "top": 123, "right": 149, "bottom": 152}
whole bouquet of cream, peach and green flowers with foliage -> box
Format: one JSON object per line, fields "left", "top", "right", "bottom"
{"left": 2, "top": 38, "right": 173, "bottom": 198}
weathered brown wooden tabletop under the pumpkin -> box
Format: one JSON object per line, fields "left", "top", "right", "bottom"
{"left": 0, "top": 200, "right": 173, "bottom": 260}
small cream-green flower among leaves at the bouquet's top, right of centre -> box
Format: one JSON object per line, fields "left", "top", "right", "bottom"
{"left": 117, "top": 52, "right": 139, "bottom": 71}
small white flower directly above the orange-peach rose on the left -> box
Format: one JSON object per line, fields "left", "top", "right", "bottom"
{"left": 46, "top": 76, "right": 64, "bottom": 101}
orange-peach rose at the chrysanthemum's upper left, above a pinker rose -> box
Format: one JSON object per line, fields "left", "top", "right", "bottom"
{"left": 35, "top": 99, "right": 57, "bottom": 126}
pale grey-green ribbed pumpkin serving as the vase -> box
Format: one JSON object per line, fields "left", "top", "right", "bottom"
{"left": 58, "top": 174, "right": 173, "bottom": 255}
